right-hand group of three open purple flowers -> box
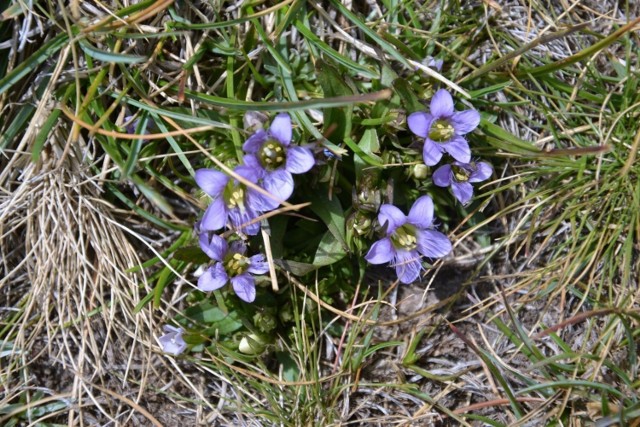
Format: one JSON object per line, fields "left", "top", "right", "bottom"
{"left": 365, "top": 89, "right": 493, "bottom": 283}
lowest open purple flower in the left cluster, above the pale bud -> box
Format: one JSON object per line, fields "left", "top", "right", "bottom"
{"left": 198, "top": 233, "right": 269, "bottom": 302}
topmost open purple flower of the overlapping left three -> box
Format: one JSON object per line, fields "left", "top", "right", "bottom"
{"left": 242, "top": 113, "right": 315, "bottom": 209}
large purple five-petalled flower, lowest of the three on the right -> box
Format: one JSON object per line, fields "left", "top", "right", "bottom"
{"left": 365, "top": 196, "right": 451, "bottom": 283}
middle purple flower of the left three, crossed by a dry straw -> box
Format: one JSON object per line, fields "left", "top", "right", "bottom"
{"left": 196, "top": 166, "right": 271, "bottom": 235}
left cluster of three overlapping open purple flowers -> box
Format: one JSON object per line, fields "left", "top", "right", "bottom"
{"left": 195, "top": 113, "right": 315, "bottom": 302}
